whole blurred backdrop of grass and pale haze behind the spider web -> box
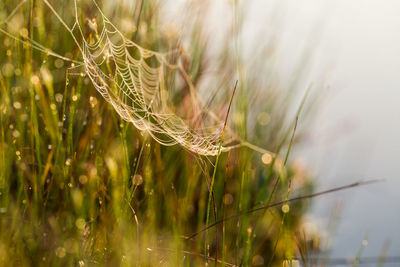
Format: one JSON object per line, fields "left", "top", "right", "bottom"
{"left": 0, "top": 0, "right": 400, "bottom": 266}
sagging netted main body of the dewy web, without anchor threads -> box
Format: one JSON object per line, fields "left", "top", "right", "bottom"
{"left": 76, "top": 3, "right": 229, "bottom": 155}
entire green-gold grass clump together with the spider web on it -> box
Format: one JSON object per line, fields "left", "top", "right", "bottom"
{"left": 0, "top": 0, "right": 328, "bottom": 266}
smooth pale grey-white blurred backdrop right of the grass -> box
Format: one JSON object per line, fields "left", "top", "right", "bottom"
{"left": 247, "top": 0, "right": 400, "bottom": 266}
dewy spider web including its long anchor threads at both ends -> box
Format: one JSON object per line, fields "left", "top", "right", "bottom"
{"left": 0, "top": 0, "right": 272, "bottom": 159}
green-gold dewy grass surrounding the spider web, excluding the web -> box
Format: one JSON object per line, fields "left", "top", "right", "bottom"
{"left": 0, "top": 0, "right": 328, "bottom": 266}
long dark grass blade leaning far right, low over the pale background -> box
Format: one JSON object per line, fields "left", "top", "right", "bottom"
{"left": 185, "top": 180, "right": 384, "bottom": 240}
